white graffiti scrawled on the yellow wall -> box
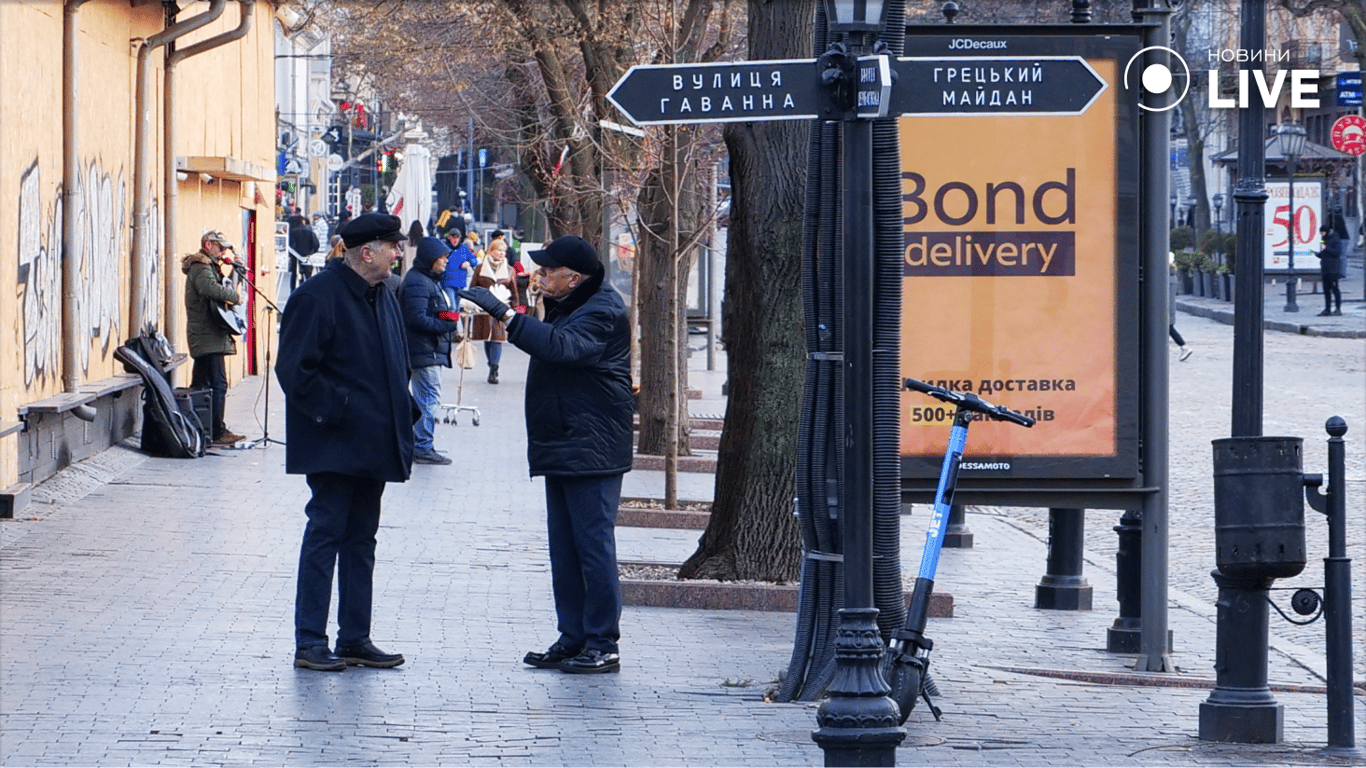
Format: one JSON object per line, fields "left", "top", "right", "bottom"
{"left": 16, "top": 160, "right": 140, "bottom": 385}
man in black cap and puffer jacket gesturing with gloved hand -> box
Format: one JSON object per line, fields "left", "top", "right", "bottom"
{"left": 460, "top": 235, "right": 632, "bottom": 674}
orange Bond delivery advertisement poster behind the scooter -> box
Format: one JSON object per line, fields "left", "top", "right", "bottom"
{"left": 900, "top": 43, "right": 1138, "bottom": 477}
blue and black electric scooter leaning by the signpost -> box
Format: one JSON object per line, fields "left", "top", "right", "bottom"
{"left": 887, "top": 379, "right": 1034, "bottom": 723}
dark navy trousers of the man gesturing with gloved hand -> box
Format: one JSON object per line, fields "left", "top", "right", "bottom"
{"left": 545, "top": 474, "right": 622, "bottom": 653}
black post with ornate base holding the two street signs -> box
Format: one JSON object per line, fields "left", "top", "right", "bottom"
{"left": 811, "top": 0, "right": 906, "bottom": 765}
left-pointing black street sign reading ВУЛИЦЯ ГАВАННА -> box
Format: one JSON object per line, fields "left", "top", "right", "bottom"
{"left": 607, "top": 59, "right": 829, "bottom": 126}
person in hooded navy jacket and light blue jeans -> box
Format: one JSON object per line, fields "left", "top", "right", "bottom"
{"left": 402, "top": 238, "right": 460, "bottom": 465}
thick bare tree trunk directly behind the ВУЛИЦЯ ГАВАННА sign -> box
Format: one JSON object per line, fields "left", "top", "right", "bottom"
{"left": 679, "top": 0, "right": 816, "bottom": 581}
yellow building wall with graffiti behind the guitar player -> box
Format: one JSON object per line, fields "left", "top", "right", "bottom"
{"left": 0, "top": 0, "right": 276, "bottom": 491}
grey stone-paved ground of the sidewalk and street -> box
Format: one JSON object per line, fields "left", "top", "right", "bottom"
{"left": 0, "top": 300, "right": 1366, "bottom": 767}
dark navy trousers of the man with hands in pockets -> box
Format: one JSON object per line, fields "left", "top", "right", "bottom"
{"left": 294, "top": 471, "right": 384, "bottom": 648}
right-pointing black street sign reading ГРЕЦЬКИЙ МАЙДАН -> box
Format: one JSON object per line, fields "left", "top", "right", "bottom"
{"left": 891, "top": 56, "right": 1109, "bottom": 118}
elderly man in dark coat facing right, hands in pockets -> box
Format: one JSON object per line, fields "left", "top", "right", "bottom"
{"left": 275, "top": 213, "right": 415, "bottom": 671}
